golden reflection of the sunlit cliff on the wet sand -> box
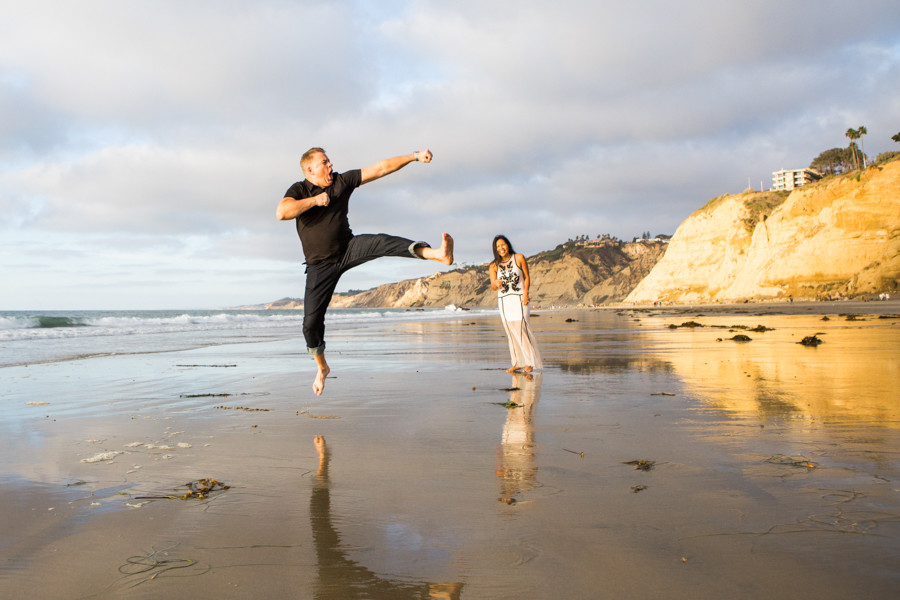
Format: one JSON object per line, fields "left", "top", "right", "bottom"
{"left": 632, "top": 315, "right": 900, "bottom": 428}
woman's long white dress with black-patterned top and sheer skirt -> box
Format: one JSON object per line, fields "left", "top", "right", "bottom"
{"left": 497, "top": 257, "right": 544, "bottom": 369}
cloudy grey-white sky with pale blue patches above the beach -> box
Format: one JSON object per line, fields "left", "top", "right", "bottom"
{"left": 0, "top": 0, "right": 900, "bottom": 310}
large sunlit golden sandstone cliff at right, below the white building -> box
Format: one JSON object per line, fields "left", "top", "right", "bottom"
{"left": 625, "top": 160, "right": 900, "bottom": 303}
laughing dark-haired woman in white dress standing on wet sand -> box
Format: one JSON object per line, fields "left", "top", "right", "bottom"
{"left": 490, "top": 235, "right": 543, "bottom": 373}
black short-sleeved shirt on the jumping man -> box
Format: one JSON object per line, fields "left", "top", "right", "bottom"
{"left": 285, "top": 169, "right": 362, "bottom": 265}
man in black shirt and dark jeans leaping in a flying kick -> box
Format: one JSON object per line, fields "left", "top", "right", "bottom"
{"left": 275, "top": 148, "right": 453, "bottom": 396}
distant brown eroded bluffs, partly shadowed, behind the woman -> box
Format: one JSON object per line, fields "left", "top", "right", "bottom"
{"left": 266, "top": 240, "right": 666, "bottom": 308}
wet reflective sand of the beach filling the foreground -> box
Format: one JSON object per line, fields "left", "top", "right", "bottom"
{"left": 0, "top": 301, "right": 900, "bottom": 599}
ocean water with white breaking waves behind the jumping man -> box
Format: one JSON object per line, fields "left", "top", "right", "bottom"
{"left": 0, "top": 306, "right": 486, "bottom": 367}
